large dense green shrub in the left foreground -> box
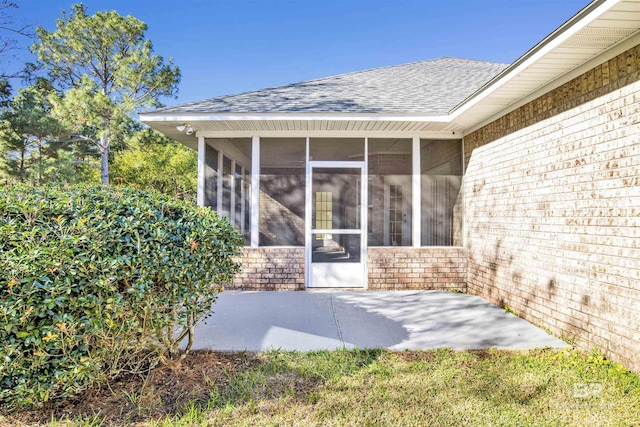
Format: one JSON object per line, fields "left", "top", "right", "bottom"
{"left": 0, "top": 186, "right": 242, "bottom": 406}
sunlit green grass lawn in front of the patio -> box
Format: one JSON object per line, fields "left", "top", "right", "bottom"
{"left": 5, "top": 349, "right": 640, "bottom": 427}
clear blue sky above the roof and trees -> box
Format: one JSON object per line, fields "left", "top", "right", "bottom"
{"left": 14, "top": 0, "right": 589, "bottom": 105}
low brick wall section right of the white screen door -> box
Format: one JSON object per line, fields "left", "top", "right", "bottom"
{"left": 367, "top": 247, "right": 467, "bottom": 292}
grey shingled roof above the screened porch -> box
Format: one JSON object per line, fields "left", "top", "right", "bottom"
{"left": 154, "top": 58, "right": 508, "bottom": 115}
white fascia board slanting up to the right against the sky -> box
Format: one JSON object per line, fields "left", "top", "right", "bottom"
{"left": 450, "top": 0, "right": 621, "bottom": 121}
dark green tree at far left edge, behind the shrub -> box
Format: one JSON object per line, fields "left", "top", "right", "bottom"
{"left": 0, "top": 79, "right": 62, "bottom": 184}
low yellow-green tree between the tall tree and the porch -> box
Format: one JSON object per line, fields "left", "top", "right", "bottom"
{"left": 111, "top": 129, "right": 198, "bottom": 201}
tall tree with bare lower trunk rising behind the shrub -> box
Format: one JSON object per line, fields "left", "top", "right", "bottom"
{"left": 32, "top": 4, "right": 180, "bottom": 184}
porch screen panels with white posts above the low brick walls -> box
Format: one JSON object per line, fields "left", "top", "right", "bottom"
{"left": 198, "top": 137, "right": 463, "bottom": 251}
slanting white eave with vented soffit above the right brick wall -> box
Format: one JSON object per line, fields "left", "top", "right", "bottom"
{"left": 452, "top": 0, "right": 640, "bottom": 130}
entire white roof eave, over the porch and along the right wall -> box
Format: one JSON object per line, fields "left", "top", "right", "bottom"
{"left": 140, "top": 0, "right": 640, "bottom": 143}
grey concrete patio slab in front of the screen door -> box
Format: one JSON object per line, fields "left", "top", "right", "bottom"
{"left": 194, "top": 291, "right": 568, "bottom": 351}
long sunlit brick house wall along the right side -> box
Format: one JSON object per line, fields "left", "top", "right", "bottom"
{"left": 465, "top": 42, "right": 640, "bottom": 371}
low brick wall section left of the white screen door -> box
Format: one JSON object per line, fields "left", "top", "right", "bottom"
{"left": 227, "top": 247, "right": 304, "bottom": 291}
